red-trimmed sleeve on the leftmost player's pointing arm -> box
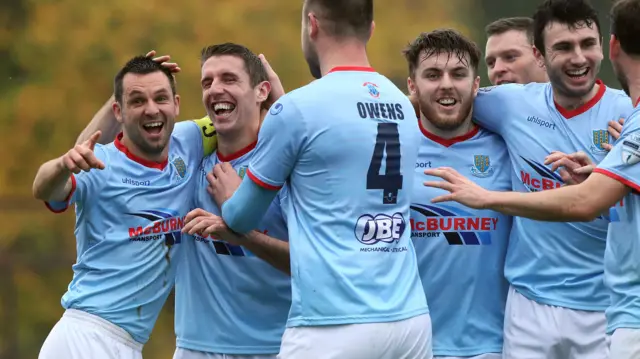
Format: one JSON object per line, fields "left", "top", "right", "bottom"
{"left": 45, "top": 144, "right": 109, "bottom": 213}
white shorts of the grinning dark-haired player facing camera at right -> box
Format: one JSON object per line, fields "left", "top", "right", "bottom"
{"left": 503, "top": 287, "right": 604, "bottom": 359}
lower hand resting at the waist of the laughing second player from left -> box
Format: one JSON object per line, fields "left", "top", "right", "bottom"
{"left": 182, "top": 208, "right": 241, "bottom": 244}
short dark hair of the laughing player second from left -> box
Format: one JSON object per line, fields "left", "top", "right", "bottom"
{"left": 200, "top": 42, "right": 269, "bottom": 86}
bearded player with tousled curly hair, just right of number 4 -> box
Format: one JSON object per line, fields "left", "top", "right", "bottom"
{"left": 404, "top": 30, "right": 512, "bottom": 359}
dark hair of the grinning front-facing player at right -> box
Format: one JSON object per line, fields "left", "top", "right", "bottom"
{"left": 533, "top": 0, "right": 602, "bottom": 55}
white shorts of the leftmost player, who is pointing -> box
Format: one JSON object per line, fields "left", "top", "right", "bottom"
{"left": 38, "top": 309, "right": 142, "bottom": 359}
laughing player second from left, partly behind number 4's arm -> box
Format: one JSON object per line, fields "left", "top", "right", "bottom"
{"left": 174, "top": 43, "right": 291, "bottom": 359}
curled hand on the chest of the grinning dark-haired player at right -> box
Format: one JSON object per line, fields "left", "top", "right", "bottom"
{"left": 544, "top": 151, "right": 596, "bottom": 185}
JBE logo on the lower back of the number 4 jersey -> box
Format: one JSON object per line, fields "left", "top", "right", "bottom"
{"left": 354, "top": 213, "right": 406, "bottom": 245}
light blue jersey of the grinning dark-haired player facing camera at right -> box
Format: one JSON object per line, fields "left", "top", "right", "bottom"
{"left": 474, "top": 81, "right": 632, "bottom": 311}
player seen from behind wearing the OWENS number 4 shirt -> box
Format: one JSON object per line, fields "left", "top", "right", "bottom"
{"left": 192, "top": 0, "right": 432, "bottom": 359}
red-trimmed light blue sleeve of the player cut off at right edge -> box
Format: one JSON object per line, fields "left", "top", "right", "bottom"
{"left": 594, "top": 111, "right": 640, "bottom": 192}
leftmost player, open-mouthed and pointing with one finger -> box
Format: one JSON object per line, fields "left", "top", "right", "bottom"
{"left": 33, "top": 56, "right": 204, "bottom": 359}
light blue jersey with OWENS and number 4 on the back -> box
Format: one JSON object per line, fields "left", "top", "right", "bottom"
{"left": 247, "top": 68, "right": 428, "bottom": 327}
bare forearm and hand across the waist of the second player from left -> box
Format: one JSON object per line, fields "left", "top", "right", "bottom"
{"left": 182, "top": 208, "right": 291, "bottom": 275}
